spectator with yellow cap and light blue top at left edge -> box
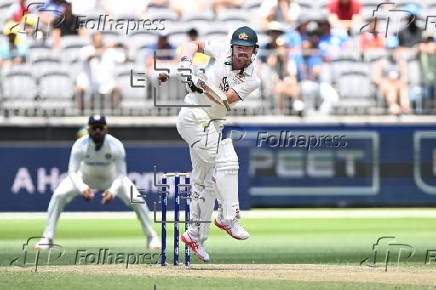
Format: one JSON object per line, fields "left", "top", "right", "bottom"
{"left": 0, "top": 22, "right": 27, "bottom": 66}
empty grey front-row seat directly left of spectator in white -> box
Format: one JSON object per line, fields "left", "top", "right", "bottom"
{"left": 38, "top": 71, "right": 75, "bottom": 116}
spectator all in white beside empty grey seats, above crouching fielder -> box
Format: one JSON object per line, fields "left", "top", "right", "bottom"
{"left": 77, "top": 32, "right": 127, "bottom": 110}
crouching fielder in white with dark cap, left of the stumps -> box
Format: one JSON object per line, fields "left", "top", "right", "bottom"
{"left": 35, "top": 115, "right": 161, "bottom": 250}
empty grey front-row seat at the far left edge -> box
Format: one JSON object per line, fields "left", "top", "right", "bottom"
{"left": 2, "top": 66, "right": 37, "bottom": 116}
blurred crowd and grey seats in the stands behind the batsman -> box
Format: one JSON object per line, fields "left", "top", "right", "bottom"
{"left": 0, "top": 0, "right": 436, "bottom": 116}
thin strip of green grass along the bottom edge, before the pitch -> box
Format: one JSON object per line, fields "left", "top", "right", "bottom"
{"left": 0, "top": 272, "right": 431, "bottom": 290}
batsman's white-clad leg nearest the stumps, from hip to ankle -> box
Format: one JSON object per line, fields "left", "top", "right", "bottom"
{"left": 177, "top": 108, "right": 221, "bottom": 243}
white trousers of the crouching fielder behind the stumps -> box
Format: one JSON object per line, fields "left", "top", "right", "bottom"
{"left": 43, "top": 177, "right": 157, "bottom": 239}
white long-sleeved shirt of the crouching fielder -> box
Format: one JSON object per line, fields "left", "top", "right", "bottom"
{"left": 68, "top": 134, "right": 127, "bottom": 195}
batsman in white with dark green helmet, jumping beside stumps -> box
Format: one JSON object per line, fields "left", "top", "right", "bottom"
{"left": 171, "top": 26, "right": 260, "bottom": 261}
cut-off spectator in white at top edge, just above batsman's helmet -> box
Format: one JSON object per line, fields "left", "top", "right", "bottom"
{"left": 260, "top": 0, "right": 301, "bottom": 28}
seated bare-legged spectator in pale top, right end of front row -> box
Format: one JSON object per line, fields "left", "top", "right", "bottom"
{"left": 374, "top": 40, "right": 410, "bottom": 115}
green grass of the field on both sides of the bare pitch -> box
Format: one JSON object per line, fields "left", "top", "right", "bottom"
{"left": 0, "top": 210, "right": 436, "bottom": 289}
